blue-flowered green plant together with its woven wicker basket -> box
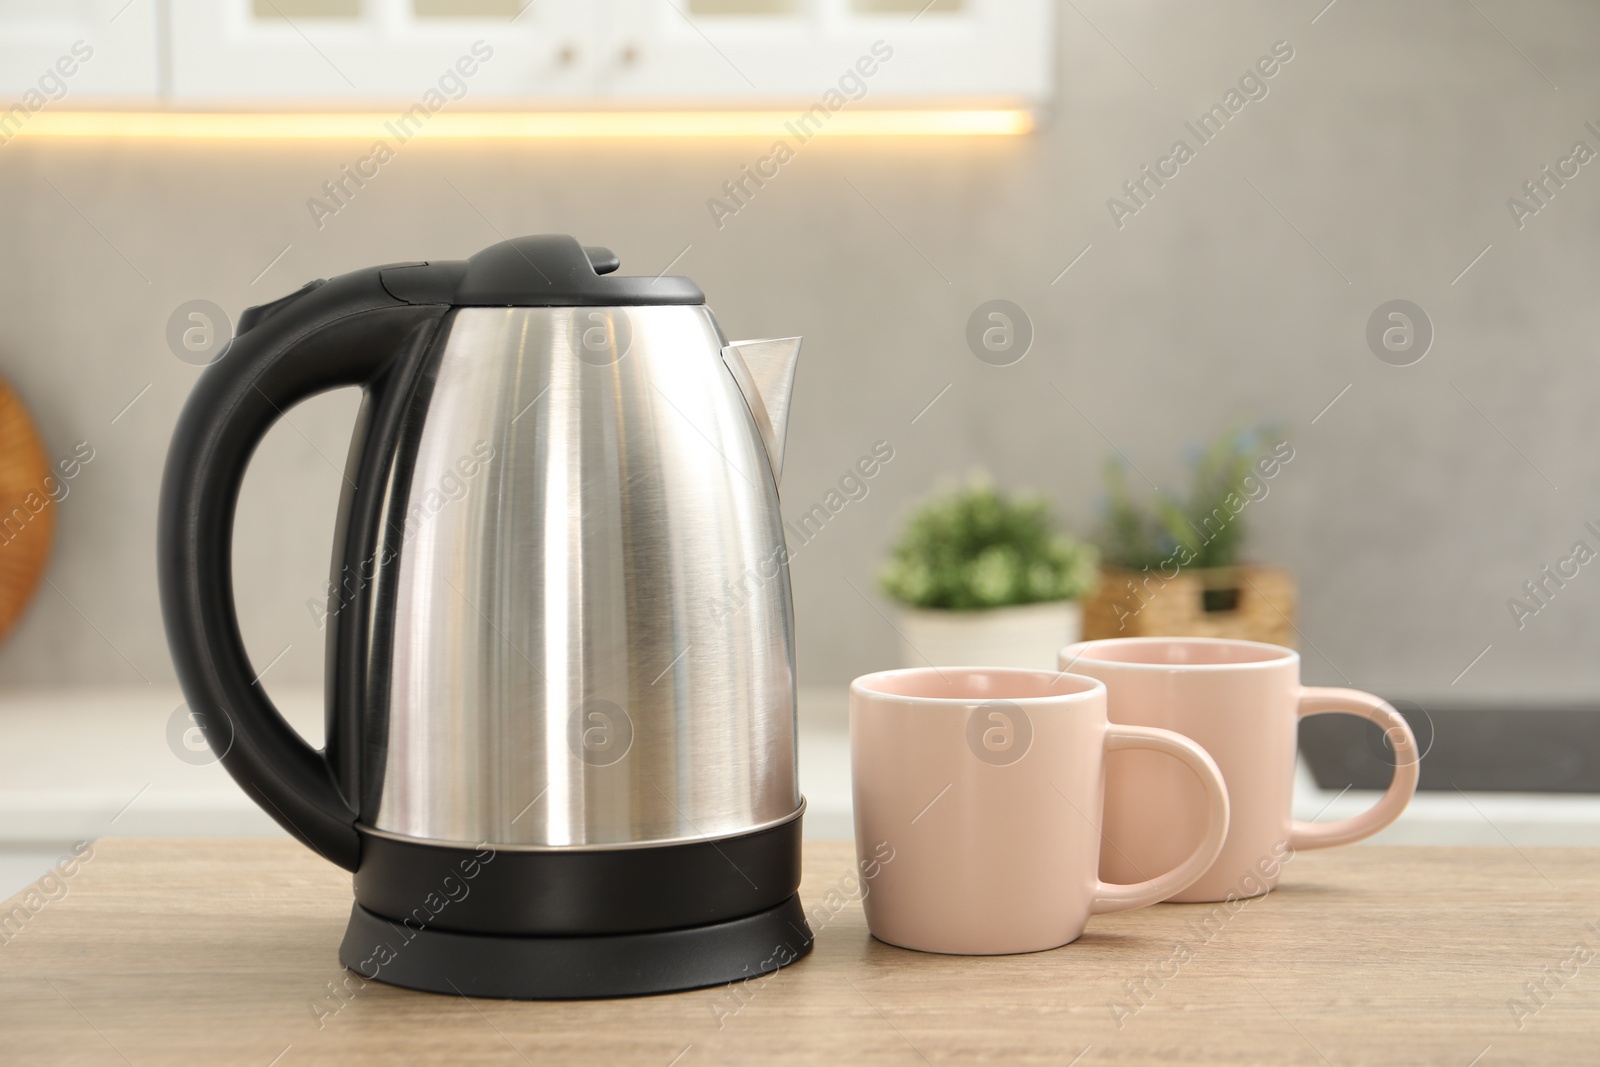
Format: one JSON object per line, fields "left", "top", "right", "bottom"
{"left": 1083, "top": 426, "right": 1296, "bottom": 645}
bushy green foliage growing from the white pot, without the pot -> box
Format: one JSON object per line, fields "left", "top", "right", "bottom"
{"left": 880, "top": 478, "right": 1098, "bottom": 611}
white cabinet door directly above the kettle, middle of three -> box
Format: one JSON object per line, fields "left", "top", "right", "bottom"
{"left": 168, "top": 0, "right": 595, "bottom": 103}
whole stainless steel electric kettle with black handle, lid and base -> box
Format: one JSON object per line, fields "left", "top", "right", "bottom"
{"left": 158, "top": 235, "right": 811, "bottom": 998}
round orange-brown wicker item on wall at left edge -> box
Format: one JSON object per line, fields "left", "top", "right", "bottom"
{"left": 0, "top": 381, "right": 59, "bottom": 638}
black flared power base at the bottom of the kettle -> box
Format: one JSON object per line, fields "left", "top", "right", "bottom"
{"left": 339, "top": 894, "right": 813, "bottom": 1000}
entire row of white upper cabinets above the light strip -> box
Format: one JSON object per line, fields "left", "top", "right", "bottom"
{"left": 0, "top": 0, "right": 1054, "bottom": 110}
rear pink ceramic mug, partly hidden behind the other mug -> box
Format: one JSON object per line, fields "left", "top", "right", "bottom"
{"left": 1061, "top": 637, "right": 1418, "bottom": 901}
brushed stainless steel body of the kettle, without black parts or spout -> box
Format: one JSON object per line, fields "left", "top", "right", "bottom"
{"left": 366, "top": 306, "right": 800, "bottom": 848}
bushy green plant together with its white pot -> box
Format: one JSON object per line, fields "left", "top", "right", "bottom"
{"left": 880, "top": 478, "right": 1096, "bottom": 667}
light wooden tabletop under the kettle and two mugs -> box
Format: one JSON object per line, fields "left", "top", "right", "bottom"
{"left": 0, "top": 840, "right": 1600, "bottom": 1067}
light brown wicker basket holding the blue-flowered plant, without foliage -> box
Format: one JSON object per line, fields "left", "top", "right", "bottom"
{"left": 1083, "top": 565, "right": 1299, "bottom": 648}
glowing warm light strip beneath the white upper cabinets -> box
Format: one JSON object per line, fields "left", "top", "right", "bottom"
{"left": 0, "top": 109, "right": 1034, "bottom": 142}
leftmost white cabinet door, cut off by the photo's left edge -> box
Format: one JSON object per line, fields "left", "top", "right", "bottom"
{"left": 0, "top": 0, "right": 158, "bottom": 101}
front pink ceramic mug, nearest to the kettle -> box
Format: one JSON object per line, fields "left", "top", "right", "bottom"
{"left": 850, "top": 667, "right": 1229, "bottom": 955}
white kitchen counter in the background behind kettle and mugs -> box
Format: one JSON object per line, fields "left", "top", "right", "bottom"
{"left": 0, "top": 686, "right": 1600, "bottom": 857}
